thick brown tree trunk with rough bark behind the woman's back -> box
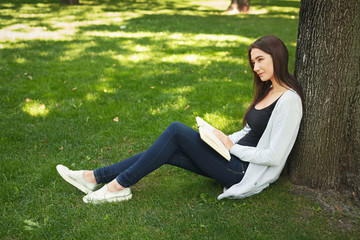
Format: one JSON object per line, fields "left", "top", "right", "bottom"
{"left": 289, "top": 0, "right": 360, "bottom": 202}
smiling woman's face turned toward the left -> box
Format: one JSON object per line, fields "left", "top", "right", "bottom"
{"left": 250, "top": 48, "right": 275, "bottom": 82}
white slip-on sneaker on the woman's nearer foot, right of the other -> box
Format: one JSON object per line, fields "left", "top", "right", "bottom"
{"left": 83, "top": 185, "right": 132, "bottom": 204}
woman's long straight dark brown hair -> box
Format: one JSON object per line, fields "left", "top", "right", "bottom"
{"left": 243, "top": 35, "right": 304, "bottom": 126}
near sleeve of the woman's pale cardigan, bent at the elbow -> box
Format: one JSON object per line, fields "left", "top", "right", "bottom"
{"left": 230, "top": 95, "right": 302, "bottom": 166}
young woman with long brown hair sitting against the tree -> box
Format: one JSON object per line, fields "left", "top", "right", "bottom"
{"left": 56, "top": 35, "right": 302, "bottom": 203}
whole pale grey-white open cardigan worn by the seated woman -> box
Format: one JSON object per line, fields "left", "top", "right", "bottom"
{"left": 218, "top": 89, "right": 302, "bottom": 200}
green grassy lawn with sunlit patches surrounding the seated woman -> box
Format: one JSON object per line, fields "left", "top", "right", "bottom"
{"left": 0, "top": 0, "right": 359, "bottom": 239}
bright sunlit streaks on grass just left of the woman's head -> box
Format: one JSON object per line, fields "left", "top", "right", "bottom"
{"left": 86, "top": 31, "right": 254, "bottom": 65}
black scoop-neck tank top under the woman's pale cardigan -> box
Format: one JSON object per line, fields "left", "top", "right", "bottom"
{"left": 237, "top": 99, "right": 279, "bottom": 147}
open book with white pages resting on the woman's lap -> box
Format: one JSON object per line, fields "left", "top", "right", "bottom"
{"left": 196, "top": 117, "right": 231, "bottom": 161}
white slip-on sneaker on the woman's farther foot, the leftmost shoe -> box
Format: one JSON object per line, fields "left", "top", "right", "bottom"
{"left": 56, "top": 165, "right": 99, "bottom": 194}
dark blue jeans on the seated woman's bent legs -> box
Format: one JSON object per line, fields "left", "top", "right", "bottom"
{"left": 94, "top": 122, "right": 248, "bottom": 188}
